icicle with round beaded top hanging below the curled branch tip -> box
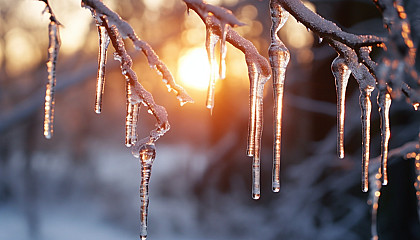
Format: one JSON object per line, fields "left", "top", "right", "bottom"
{"left": 139, "top": 144, "right": 156, "bottom": 240}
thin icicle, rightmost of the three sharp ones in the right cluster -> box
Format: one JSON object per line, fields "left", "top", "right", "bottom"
{"left": 377, "top": 90, "right": 392, "bottom": 185}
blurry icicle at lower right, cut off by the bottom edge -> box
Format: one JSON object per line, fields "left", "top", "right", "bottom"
{"left": 368, "top": 173, "right": 382, "bottom": 240}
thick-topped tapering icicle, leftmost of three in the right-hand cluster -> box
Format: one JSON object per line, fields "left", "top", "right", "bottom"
{"left": 331, "top": 56, "right": 351, "bottom": 158}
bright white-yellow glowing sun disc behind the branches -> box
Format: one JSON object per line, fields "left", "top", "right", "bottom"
{"left": 178, "top": 47, "right": 210, "bottom": 91}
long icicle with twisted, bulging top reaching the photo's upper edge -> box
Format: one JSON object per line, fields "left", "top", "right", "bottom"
{"left": 269, "top": 1, "right": 290, "bottom": 192}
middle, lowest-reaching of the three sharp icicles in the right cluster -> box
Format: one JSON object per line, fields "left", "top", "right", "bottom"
{"left": 359, "top": 86, "right": 374, "bottom": 192}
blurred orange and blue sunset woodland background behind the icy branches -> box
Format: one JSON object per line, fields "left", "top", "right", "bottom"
{"left": 0, "top": 0, "right": 420, "bottom": 240}
